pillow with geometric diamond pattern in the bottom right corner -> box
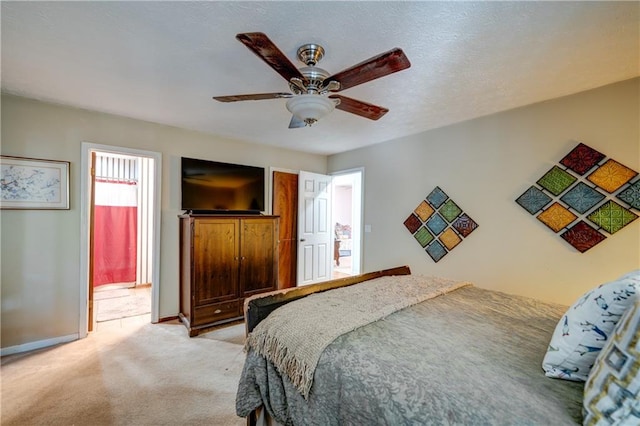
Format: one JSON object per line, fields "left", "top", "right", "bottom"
{"left": 583, "top": 301, "right": 640, "bottom": 425}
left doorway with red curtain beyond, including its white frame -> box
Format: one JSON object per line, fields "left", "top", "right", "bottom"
{"left": 80, "top": 143, "right": 161, "bottom": 337}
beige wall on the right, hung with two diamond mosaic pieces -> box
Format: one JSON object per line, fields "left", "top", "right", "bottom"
{"left": 329, "top": 79, "right": 640, "bottom": 304}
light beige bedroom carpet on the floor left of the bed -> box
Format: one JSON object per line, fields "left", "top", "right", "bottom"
{"left": 0, "top": 321, "right": 246, "bottom": 426}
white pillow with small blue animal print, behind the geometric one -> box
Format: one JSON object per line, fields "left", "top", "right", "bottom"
{"left": 542, "top": 269, "right": 640, "bottom": 381}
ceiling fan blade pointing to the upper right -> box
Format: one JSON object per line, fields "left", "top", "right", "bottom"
{"left": 323, "top": 47, "right": 411, "bottom": 90}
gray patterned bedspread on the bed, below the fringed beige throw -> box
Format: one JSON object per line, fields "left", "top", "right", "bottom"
{"left": 236, "top": 287, "right": 583, "bottom": 426}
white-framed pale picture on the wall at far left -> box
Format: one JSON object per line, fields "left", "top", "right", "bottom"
{"left": 0, "top": 155, "right": 70, "bottom": 210}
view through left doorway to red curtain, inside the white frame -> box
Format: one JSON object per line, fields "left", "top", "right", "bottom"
{"left": 89, "top": 151, "right": 155, "bottom": 330}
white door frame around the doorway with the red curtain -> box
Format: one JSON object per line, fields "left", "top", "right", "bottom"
{"left": 78, "top": 142, "right": 162, "bottom": 339}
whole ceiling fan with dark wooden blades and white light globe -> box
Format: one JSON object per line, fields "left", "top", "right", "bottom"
{"left": 213, "top": 32, "right": 411, "bottom": 129}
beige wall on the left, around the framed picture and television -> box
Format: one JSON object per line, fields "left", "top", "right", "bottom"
{"left": 0, "top": 95, "right": 326, "bottom": 348}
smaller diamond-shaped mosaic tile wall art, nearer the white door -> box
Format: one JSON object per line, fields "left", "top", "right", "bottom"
{"left": 404, "top": 186, "right": 478, "bottom": 262}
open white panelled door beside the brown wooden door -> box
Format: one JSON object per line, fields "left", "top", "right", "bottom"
{"left": 297, "top": 171, "right": 333, "bottom": 286}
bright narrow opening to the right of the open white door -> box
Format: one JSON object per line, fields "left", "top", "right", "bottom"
{"left": 332, "top": 169, "right": 363, "bottom": 278}
